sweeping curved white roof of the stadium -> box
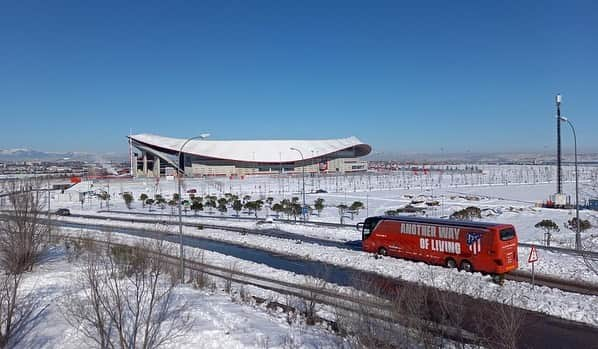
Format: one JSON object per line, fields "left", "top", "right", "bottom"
{"left": 129, "top": 134, "right": 372, "bottom": 163}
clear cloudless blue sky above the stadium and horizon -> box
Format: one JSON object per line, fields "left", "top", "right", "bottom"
{"left": 0, "top": 0, "right": 598, "bottom": 152}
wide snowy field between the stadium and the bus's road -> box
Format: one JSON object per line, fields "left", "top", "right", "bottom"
{"left": 44, "top": 165, "right": 598, "bottom": 248}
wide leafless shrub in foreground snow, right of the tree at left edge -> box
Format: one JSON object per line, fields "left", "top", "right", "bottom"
{"left": 61, "top": 237, "right": 191, "bottom": 349}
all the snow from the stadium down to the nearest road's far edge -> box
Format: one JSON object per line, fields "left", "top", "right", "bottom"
{"left": 35, "top": 165, "right": 598, "bottom": 326}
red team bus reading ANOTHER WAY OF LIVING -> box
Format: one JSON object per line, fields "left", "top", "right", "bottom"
{"left": 357, "top": 216, "right": 518, "bottom": 280}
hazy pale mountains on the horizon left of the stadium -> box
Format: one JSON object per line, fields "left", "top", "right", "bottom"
{"left": 0, "top": 149, "right": 127, "bottom": 162}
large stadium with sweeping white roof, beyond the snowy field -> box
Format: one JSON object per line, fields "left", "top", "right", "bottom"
{"left": 129, "top": 134, "right": 372, "bottom": 177}
